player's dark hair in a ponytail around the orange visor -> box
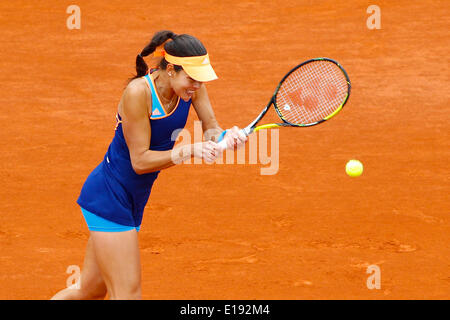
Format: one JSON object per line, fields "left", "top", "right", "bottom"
{"left": 130, "top": 30, "right": 207, "bottom": 81}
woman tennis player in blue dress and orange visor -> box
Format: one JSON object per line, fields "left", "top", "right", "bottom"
{"left": 52, "top": 30, "right": 247, "bottom": 299}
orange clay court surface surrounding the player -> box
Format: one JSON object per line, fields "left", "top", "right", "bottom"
{"left": 0, "top": 0, "right": 450, "bottom": 299}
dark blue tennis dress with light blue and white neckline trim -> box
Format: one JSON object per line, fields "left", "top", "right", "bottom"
{"left": 77, "top": 75, "right": 191, "bottom": 227}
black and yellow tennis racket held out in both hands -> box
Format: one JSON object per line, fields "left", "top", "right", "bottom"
{"left": 218, "top": 58, "right": 351, "bottom": 150}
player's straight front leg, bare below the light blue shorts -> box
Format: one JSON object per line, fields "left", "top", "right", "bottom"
{"left": 91, "top": 229, "right": 142, "bottom": 300}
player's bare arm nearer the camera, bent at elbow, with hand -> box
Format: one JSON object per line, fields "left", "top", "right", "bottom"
{"left": 122, "top": 80, "right": 218, "bottom": 174}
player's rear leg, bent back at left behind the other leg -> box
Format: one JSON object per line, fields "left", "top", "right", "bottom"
{"left": 52, "top": 238, "right": 106, "bottom": 300}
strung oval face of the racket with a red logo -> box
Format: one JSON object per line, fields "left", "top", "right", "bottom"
{"left": 276, "top": 60, "right": 348, "bottom": 124}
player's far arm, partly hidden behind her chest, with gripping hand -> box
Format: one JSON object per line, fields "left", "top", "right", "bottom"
{"left": 192, "top": 84, "right": 247, "bottom": 147}
